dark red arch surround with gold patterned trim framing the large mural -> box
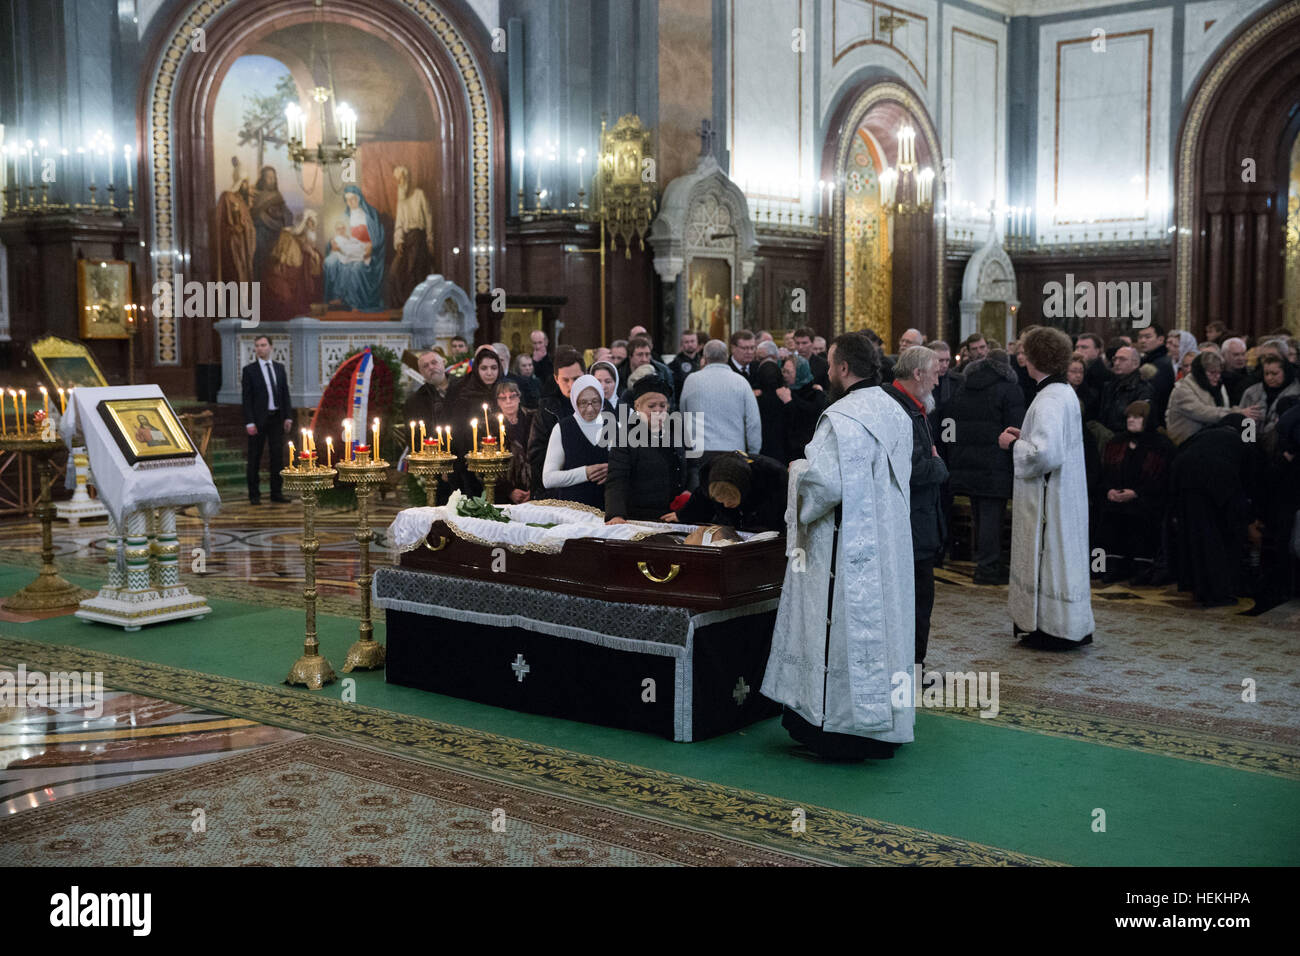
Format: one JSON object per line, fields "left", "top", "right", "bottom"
{"left": 138, "top": 0, "right": 504, "bottom": 377}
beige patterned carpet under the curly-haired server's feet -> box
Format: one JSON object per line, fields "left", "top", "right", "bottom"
{"left": 926, "top": 572, "right": 1300, "bottom": 754}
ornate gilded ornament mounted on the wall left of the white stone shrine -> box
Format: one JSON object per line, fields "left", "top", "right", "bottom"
{"left": 593, "top": 113, "right": 658, "bottom": 259}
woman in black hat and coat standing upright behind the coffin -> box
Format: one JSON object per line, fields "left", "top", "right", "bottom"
{"left": 605, "top": 375, "right": 686, "bottom": 524}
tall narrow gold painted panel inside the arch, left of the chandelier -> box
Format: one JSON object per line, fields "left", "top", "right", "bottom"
{"left": 844, "top": 129, "right": 893, "bottom": 342}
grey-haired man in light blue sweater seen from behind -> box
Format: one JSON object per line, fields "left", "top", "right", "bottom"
{"left": 681, "top": 338, "right": 763, "bottom": 492}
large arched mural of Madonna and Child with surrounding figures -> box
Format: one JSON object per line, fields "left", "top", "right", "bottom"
{"left": 211, "top": 23, "right": 441, "bottom": 321}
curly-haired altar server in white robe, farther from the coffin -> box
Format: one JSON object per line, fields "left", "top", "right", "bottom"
{"left": 998, "top": 328, "right": 1093, "bottom": 650}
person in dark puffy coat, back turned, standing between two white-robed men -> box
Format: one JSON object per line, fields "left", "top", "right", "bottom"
{"left": 944, "top": 349, "right": 1024, "bottom": 584}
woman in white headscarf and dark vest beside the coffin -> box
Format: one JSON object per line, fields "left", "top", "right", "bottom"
{"left": 543, "top": 375, "right": 610, "bottom": 511}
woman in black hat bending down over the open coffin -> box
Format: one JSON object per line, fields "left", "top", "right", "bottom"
{"left": 676, "top": 451, "right": 788, "bottom": 532}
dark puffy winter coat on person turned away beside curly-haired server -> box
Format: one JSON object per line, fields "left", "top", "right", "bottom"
{"left": 940, "top": 359, "right": 1024, "bottom": 498}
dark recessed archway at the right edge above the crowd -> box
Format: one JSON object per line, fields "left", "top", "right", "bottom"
{"left": 1174, "top": 4, "right": 1300, "bottom": 336}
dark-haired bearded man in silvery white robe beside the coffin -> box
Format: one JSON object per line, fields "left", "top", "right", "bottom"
{"left": 762, "top": 333, "right": 917, "bottom": 760}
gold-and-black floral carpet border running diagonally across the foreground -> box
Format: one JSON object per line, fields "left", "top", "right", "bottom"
{"left": 0, "top": 639, "right": 1052, "bottom": 866}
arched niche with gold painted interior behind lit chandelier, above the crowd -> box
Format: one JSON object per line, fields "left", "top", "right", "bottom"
{"left": 823, "top": 79, "right": 944, "bottom": 349}
